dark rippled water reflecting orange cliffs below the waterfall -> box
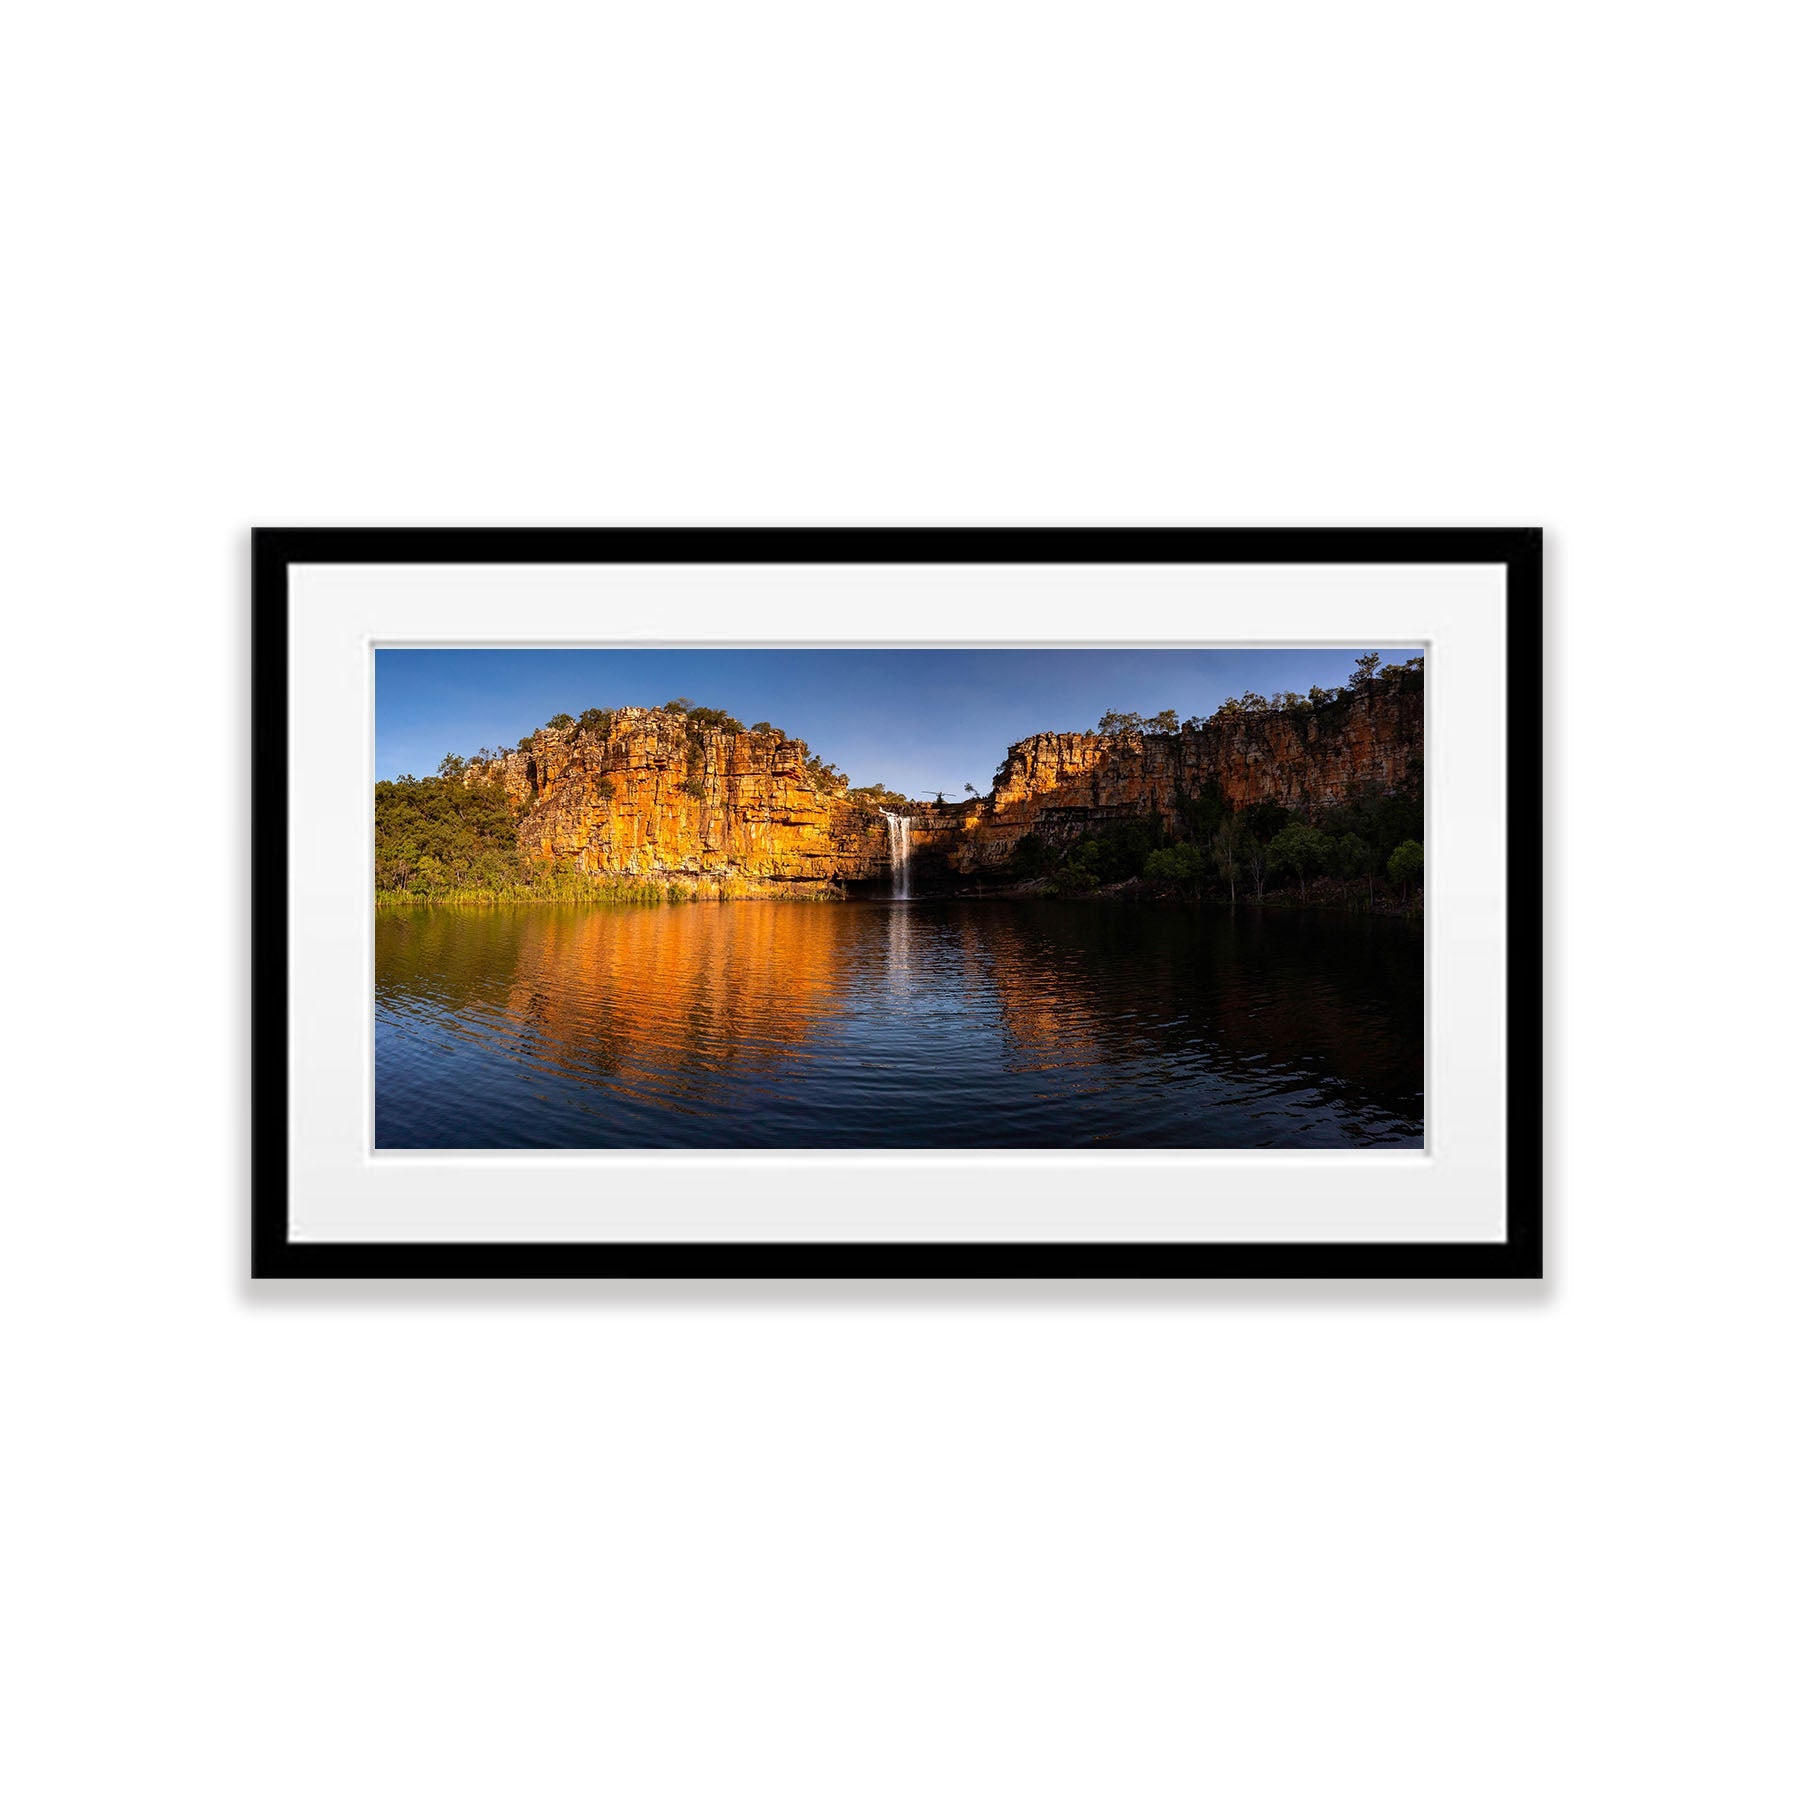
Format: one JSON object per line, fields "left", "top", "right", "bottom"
{"left": 374, "top": 900, "right": 1424, "bottom": 1148}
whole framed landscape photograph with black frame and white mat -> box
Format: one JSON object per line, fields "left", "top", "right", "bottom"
{"left": 252, "top": 529, "right": 1543, "bottom": 1278}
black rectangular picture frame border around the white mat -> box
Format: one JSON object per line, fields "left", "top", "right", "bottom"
{"left": 250, "top": 527, "right": 1544, "bottom": 1280}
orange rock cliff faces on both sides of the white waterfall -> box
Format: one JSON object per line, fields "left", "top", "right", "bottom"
{"left": 464, "top": 684, "right": 1424, "bottom": 893}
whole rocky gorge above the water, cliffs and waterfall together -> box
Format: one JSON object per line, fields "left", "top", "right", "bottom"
{"left": 376, "top": 664, "right": 1424, "bottom": 898}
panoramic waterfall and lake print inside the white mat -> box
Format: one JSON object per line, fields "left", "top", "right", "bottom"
{"left": 373, "top": 643, "right": 1431, "bottom": 1152}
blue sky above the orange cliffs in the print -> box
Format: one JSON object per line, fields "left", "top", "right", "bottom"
{"left": 374, "top": 650, "right": 1413, "bottom": 797}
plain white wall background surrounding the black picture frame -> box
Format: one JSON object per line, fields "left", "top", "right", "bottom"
{"left": 0, "top": 0, "right": 1800, "bottom": 1800}
